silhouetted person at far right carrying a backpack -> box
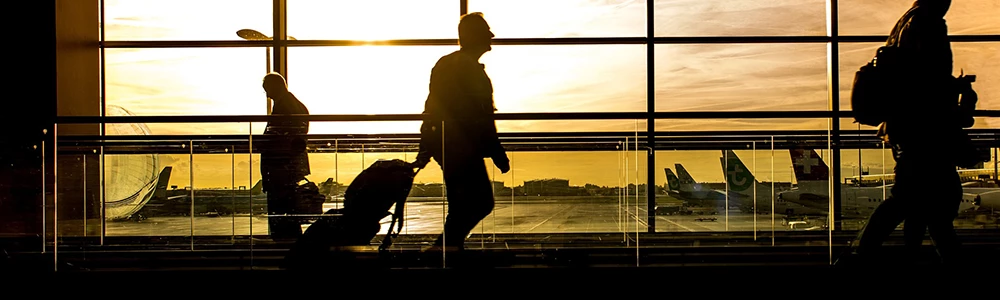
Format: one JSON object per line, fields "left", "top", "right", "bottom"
{"left": 855, "top": 0, "right": 971, "bottom": 263}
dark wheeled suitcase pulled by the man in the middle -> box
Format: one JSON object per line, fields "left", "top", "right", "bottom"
{"left": 284, "top": 159, "right": 417, "bottom": 269}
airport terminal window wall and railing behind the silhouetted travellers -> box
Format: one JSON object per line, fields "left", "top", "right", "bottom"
{"left": 0, "top": 0, "right": 1000, "bottom": 282}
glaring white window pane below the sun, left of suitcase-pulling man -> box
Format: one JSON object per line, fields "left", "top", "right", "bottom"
{"left": 288, "top": 46, "right": 452, "bottom": 116}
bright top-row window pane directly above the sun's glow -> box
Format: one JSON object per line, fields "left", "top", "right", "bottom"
{"left": 287, "top": 0, "right": 458, "bottom": 40}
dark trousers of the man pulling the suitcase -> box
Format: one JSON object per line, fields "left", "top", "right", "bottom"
{"left": 435, "top": 158, "right": 495, "bottom": 249}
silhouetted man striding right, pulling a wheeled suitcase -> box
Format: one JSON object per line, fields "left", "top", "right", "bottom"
{"left": 415, "top": 13, "right": 510, "bottom": 251}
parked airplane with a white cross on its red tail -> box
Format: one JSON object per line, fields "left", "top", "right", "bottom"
{"left": 778, "top": 149, "right": 980, "bottom": 218}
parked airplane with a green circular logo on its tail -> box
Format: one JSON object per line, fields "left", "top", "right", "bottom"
{"left": 719, "top": 150, "right": 816, "bottom": 215}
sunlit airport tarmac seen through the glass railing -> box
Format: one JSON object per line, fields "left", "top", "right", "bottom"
{"left": 106, "top": 199, "right": 992, "bottom": 236}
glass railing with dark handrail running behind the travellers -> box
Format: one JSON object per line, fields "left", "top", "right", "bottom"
{"left": 13, "top": 112, "right": 1000, "bottom": 267}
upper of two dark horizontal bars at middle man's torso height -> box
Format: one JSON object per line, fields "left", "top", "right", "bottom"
{"left": 55, "top": 110, "right": 1000, "bottom": 124}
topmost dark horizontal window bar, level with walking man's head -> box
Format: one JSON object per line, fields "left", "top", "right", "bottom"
{"left": 98, "top": 34, "right": 1000, "bottom": 49}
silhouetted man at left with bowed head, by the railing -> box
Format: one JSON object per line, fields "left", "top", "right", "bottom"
{"left": 260, "top": 73, "right": 311, "bottom": 239}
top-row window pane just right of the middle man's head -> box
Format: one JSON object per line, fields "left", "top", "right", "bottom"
{"left": 464, "top": 0, "right": 646, "bottom": 38}
